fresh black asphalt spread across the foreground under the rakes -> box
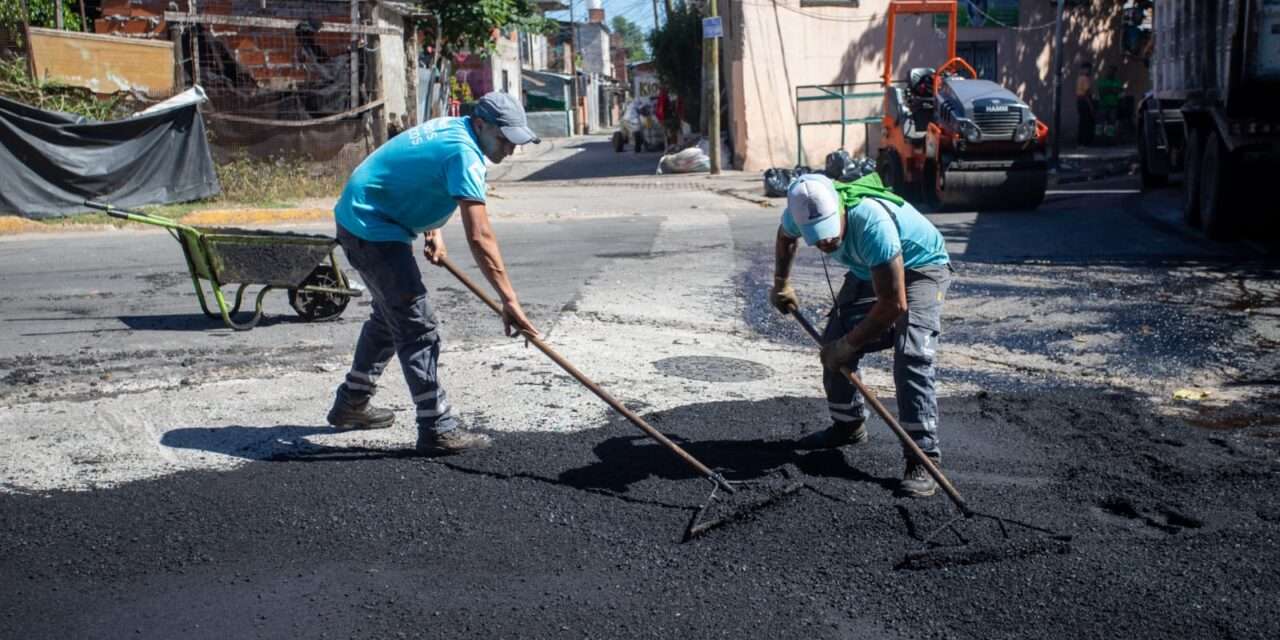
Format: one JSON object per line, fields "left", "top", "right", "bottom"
{"left": 0, "top": 389, "right": 1280, "bottom": 639}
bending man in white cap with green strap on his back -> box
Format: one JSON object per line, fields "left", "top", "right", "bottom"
{"left": 769, "top": 172, "right": 951, "bottom": 497}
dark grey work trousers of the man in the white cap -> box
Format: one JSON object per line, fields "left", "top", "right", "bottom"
{"left": 822, "top": 265, "right": 951, "bottom": 454}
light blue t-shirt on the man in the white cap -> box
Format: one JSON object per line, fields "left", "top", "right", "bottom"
{"left": 782, "top": 197, "right": 951, "bottom": 282}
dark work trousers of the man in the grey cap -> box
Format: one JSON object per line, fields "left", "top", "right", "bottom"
{"left": 338, "top": 225, "right": 458, "bottom": 434}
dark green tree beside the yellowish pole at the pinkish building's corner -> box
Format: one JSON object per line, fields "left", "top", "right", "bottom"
{"left": 649, "top": 1, "right": 703, "bottom": 127}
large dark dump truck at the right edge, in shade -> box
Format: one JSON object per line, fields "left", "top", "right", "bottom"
{"left": 1138, "top": 0, "right": 1280, "bottom": 239}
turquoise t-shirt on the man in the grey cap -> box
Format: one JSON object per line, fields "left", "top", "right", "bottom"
{"left": 334, "top": 118, "right": 488, "bottom": 242}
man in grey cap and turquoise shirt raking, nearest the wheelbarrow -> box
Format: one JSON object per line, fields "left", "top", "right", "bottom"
{"left": 328, "top": 92, "right": 540, "bottom": 454}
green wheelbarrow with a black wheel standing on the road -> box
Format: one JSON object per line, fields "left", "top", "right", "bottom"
{"left": 84, "top": 201, "right": 361, "bottom": 332}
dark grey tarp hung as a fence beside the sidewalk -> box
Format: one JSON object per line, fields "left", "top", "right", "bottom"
{"left": 0, "top": 87, "right": 221, "bottom": 218}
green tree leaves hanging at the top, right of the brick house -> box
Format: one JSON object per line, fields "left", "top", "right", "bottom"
{"left": 417, "top": 0, "right": 552, "bottom": 55}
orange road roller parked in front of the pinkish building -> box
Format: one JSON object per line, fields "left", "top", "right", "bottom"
{"left": 876, "top": 0, "right": 1048, "bottom": 210}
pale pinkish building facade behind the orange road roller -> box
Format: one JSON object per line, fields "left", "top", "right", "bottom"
{"left": 717, "top": 0, "right": 1148, "bottom": 170}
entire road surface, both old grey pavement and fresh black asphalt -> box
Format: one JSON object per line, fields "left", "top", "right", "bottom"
{"left": 0, "top": 141, "right": 1280, "bottom": 637}
